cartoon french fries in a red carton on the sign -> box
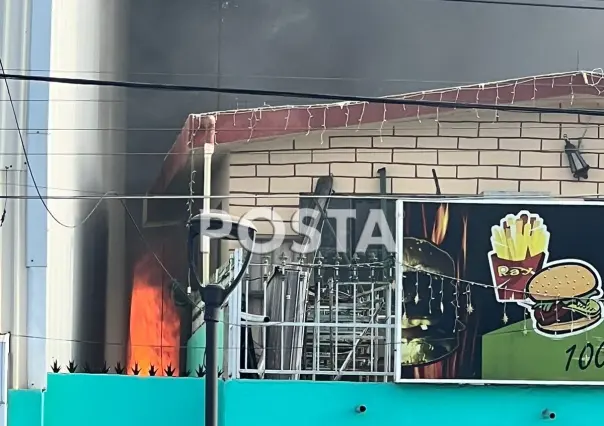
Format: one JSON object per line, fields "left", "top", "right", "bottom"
{"left": 489, "top": 211, "right": 550, "bottom": 302}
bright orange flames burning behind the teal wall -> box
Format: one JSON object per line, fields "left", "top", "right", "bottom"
{"left": 128, "top": 254, "right": 180, "bottom": 376}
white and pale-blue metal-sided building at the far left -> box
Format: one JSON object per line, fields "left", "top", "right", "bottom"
{"left": 0, "top": 0, "right": 125, "bottom": 388}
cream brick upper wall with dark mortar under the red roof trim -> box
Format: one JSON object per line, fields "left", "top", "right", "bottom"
{"left": 224, "top": 111, "right": 604, "bottom": 236}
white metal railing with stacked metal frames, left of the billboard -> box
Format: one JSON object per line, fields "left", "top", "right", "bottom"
{"left": 229, "top": 246, "right": 395, "bottom": 381}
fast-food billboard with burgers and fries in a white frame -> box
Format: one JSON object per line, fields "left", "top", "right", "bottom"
{"left": 395, "top": 199, "right": 604, "bottom": 384}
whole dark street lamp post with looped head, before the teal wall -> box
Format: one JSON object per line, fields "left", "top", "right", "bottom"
{"left": 189, "top": 212, "right": 257, "bottom": 426}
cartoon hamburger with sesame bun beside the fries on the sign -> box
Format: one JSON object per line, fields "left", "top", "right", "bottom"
{"left": 526, "top": 260, "right": 602, "bottom": 336}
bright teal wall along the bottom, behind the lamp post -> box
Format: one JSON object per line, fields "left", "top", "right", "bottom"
{"left": 8, "top": 374, "right": 604, "bottom": 426}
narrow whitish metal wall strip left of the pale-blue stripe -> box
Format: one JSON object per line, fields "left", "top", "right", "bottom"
{"left": 0, "top": 0, "right": 31, "bottom": 388}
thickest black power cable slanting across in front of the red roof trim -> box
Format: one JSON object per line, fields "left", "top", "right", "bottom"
{"left": 0, "top": 72, "right": 604, "bottom": 117}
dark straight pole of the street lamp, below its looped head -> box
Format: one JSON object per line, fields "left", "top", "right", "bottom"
{"left": 201, "top": 284, "right": 225, "bottom": 426}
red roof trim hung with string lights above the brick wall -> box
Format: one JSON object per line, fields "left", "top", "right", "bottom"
{"left": 151, "top": 72, "right": 602, "bottom": 193}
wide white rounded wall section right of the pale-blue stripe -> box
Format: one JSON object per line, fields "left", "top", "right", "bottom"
{"left": 46, "top": 0, "right": 128, "bottom": 365}
